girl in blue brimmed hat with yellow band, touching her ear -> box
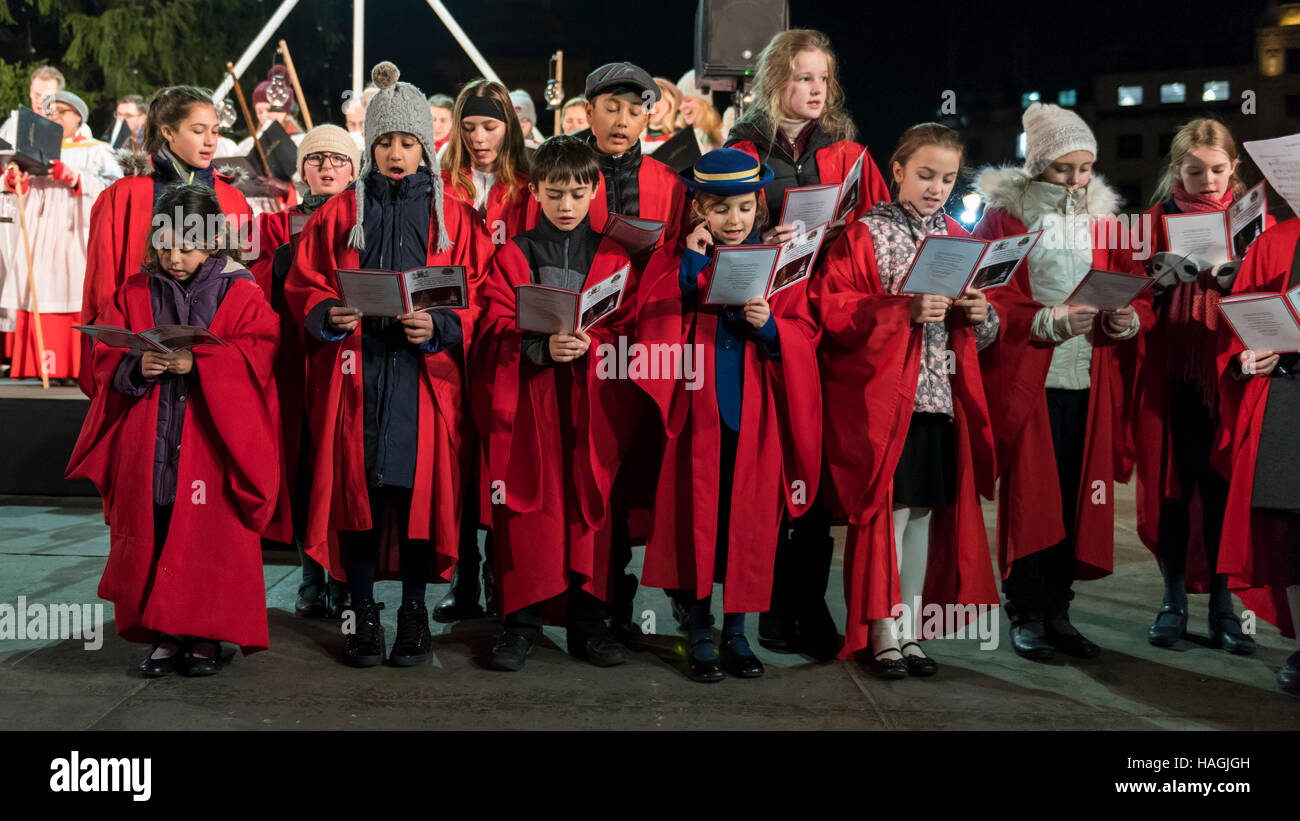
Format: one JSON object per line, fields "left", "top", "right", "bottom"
{"left": 637, "top": 148, "right": 822, "bottom": 682}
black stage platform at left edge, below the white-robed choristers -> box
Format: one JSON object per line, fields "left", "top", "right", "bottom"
{"left": 0, "top": 377, "right": 98, "bottom": 496}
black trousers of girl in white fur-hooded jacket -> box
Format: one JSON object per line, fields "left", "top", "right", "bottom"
{"left": 1002, "top": 388, "right": 1091, "bottom": 620}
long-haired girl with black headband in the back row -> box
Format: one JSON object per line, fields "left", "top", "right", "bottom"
{"left": 441, "top": 78, "right": 537, "bottom": 240}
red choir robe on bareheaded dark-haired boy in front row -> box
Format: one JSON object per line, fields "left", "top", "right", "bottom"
{"left": 471, "top": 233, "right": 637, "bottom": 613}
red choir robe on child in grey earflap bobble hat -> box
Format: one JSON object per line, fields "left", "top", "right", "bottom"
{"left": 285, "top": 191, "right": 491, "bottom": 579}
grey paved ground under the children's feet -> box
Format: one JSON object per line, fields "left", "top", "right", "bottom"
{"left": 0, "top": 480, "right": 1300, "bottom": 730}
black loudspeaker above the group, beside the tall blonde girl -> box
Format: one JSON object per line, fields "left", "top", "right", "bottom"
{"left": 696, "top": 0, "right": 790, "bottom": 88}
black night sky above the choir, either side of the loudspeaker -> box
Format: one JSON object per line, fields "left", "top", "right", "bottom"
{"left": 261, "top": 0, "right": 1268, "bottom": 160}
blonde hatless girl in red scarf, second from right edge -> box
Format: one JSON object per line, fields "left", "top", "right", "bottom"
{"left": 1134, "top": 118, "right": 1256, "bottom": 655}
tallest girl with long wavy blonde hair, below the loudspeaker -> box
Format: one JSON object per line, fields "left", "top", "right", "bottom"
{"left": 727, "top": 29, "right": 889, "bottom": 659}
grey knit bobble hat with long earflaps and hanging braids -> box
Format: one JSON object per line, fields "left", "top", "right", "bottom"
{"left": 347, "top": 60, "right": 451, "bottom": 253}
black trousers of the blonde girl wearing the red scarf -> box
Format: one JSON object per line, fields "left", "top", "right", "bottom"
{"left": 1157, "top": 382, "right": 1227, "bottom": 578}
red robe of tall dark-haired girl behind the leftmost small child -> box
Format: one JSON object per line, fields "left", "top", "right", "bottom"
{"left": 78, "top": 166, "right": 252, "bottom": 396}
